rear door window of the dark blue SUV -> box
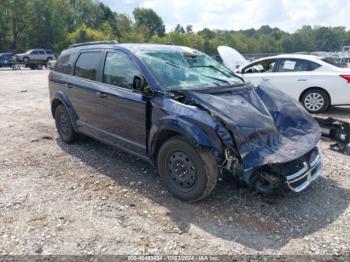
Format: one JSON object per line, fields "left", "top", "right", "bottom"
{"left": 74, "top": 52, "right": 102, "bottom": 81}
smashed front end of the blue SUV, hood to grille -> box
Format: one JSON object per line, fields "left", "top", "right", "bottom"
{"left": 178, "top": 84, "right": 322, "bottom": 193}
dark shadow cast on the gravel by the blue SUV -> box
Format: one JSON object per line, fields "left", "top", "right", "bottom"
{"left": 57, "top": 138, "right": 350, "bottom": 251}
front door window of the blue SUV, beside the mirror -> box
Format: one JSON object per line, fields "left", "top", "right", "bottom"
{"left": 102, "top": 52, "right": 140, "bottom": 89}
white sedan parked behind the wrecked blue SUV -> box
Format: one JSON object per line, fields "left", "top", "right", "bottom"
{"left": 220, "top": 47, "right": 350, "bottom": 113}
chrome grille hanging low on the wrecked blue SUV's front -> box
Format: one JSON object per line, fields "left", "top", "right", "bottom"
{"left": 285, "top": 148, "right": 323, "bottom": 192}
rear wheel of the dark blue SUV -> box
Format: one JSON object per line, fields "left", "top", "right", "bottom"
{"left": 55, "top": 105, "right": 77, "bottom": 144}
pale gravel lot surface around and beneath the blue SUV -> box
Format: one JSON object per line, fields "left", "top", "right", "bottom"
{"left": 0, "top": 70, "right": 350, "bottom": 255}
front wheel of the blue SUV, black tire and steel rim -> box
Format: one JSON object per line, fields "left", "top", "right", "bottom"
{"left": 157, "top": 136, "right": 218, "bottom": 203}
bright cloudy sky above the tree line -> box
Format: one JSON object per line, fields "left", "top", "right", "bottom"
{"left": 101, "top": 0, "right": 350, "bottom": 32}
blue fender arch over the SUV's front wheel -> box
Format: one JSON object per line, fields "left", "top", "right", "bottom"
{"left": 147, "top": 116, "right": 223, "bottom": 159}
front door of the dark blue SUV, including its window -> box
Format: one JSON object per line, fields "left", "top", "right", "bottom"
{"left": 96, "top": 51, "right": 146, "bottom": 155}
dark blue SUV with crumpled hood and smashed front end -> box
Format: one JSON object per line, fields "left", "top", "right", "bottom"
{"left": 49, "top": 42, "right": 322, "bottom": 202}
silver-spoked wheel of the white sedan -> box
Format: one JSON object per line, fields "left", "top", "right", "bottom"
{"left": 301, "top": 88, "right": 330, "bottom": 114}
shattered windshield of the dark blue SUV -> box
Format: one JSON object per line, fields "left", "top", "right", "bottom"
{"left": 138, "top": 48, "right": 243, "bottom": 91}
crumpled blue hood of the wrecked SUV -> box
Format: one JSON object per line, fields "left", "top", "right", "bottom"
{"left": 186, "top": 84, "right": 321, "bottom": 168}
